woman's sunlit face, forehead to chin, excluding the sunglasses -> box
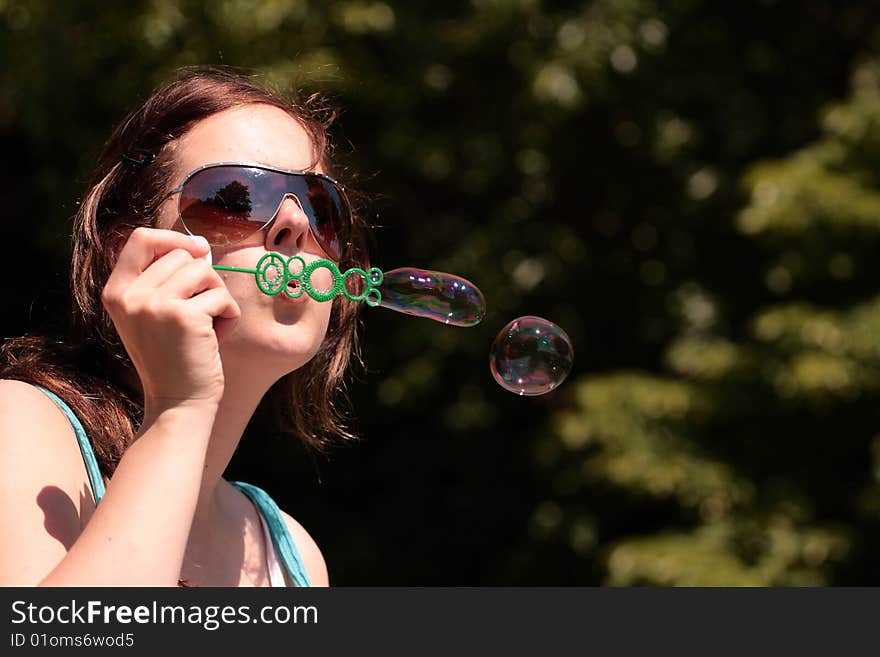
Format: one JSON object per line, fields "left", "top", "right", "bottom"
{"left": 157, "top": 104, "right": 333, "bottom": 378}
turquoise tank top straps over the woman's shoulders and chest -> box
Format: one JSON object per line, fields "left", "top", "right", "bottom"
{"left": 36, "top": 386, "right": 311, "bottom": 586}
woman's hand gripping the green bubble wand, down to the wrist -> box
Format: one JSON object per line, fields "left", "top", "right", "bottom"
{"left": 101, "top": 228, "right": 241, "bottom": 413}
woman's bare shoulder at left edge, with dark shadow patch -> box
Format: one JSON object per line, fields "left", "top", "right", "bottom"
{"left": 0, "top": 379, "right": 88, "bottom": 585}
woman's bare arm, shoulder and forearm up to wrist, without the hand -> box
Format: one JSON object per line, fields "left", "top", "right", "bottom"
{"left": 0, "top": 381, "right": 216, "bottom": 586}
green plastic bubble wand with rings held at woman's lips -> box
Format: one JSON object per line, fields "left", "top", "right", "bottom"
{"left": 212, "top": 252, "right": 384, "bottom": 306}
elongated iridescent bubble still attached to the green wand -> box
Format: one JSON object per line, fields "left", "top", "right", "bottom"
{"left": 379, "top": 267, "right": 486, "bottom": 326}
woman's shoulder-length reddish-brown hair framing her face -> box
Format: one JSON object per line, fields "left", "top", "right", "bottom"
{"left": 0, "top": 68, "right": 369, "bottom": 476}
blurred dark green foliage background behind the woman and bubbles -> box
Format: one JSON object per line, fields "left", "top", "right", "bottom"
{"left": 0, "top": 0, "right": 880, "bottom": 585}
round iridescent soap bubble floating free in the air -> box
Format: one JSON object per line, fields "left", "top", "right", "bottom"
{"left": 489, "top": 315, "right": 574, "bottom": 395}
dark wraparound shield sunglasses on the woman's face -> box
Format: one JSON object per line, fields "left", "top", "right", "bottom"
{"left": 166, "top": 162, "right": 351, "bottom": 261}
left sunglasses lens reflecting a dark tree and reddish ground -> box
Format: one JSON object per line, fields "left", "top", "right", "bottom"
{"left": 180, "top": 166, "right": 278, "bottom": 246}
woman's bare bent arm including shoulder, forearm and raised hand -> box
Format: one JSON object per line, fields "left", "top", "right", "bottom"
{"left": 0, "top": 228, "right": 241, "bottom": 586}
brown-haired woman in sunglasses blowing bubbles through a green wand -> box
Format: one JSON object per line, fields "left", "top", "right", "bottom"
{"left": 0, "top": 70, "right": 369, "bottom": 586}
